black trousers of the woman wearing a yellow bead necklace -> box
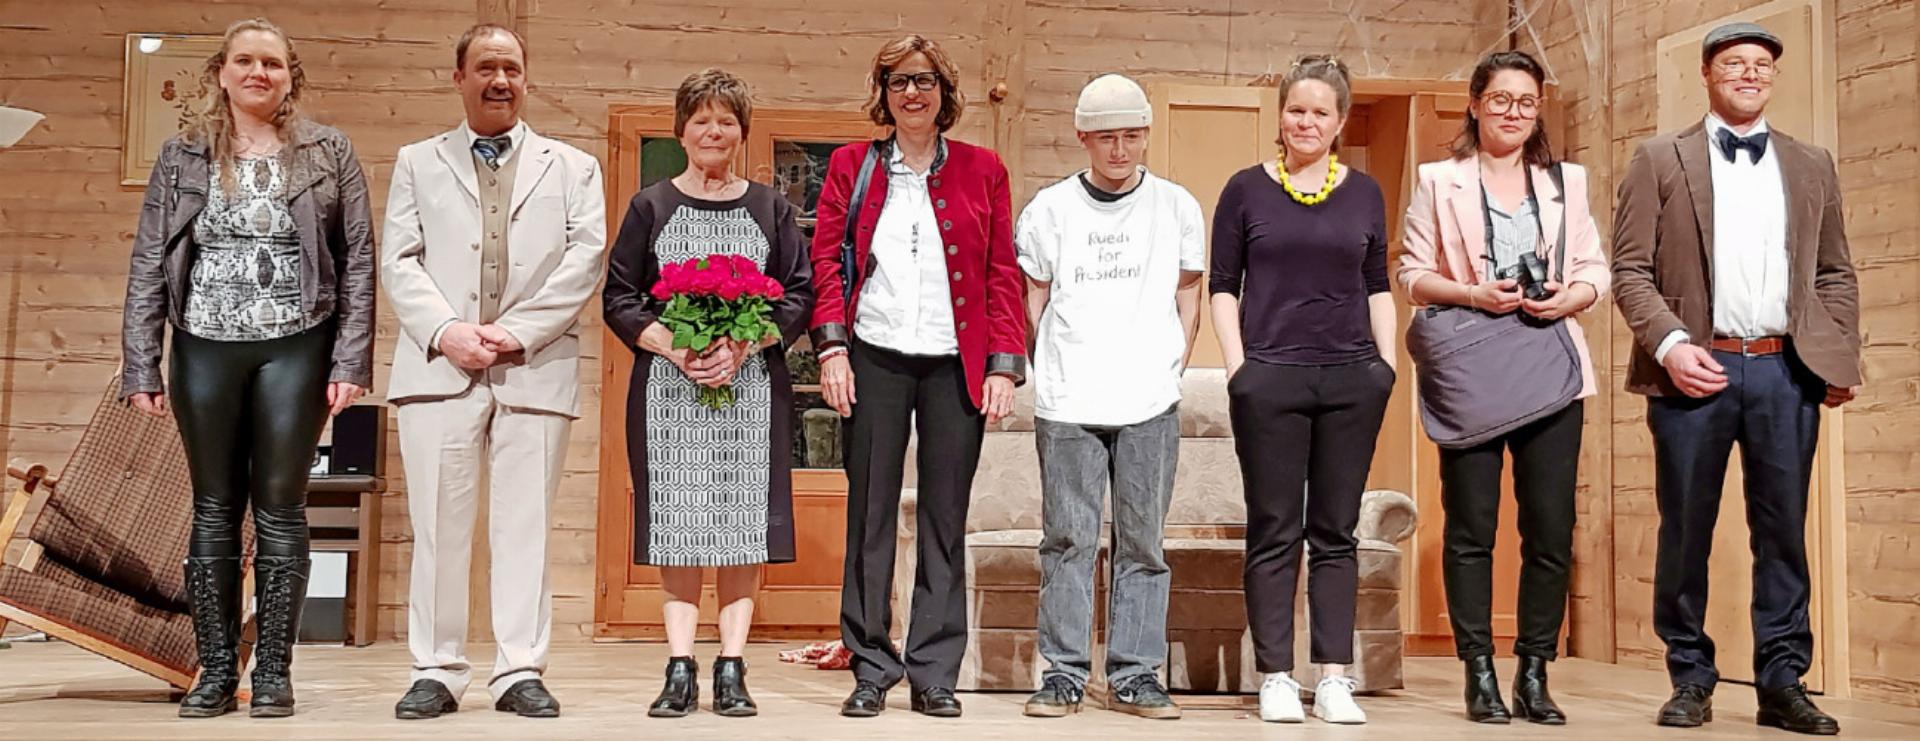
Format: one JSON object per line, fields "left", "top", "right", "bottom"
{"left": 1227, "top": 357, "right": 1394, "bottom": 672}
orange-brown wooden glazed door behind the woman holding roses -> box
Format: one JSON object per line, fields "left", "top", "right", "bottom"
{"left": 593, "top": 106, "right": 877, "bottom": 639}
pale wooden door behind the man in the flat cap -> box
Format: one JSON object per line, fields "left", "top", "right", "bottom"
{"left": 1657, "top": 0, "right": 1847, "bottom": 691}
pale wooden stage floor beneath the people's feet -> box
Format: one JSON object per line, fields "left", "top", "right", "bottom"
{"left": 0, "top": 641, "right": 1920, "bottom": 741}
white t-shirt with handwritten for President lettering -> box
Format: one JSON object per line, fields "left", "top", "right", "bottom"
{"left": 1014, "top": 169, "right": 1206, "bottom": 426}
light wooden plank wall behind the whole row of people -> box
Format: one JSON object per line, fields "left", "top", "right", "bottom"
{"left": 0, "top": 0, "right": 1920, "bottom": 703}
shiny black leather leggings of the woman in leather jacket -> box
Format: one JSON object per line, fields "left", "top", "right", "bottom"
{"left": 167, "top": 323, "right": 334, "bottom": 559}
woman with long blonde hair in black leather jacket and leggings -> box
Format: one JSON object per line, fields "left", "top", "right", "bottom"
{"left": 121, "top": 19, "right": 374, "bottom": 718}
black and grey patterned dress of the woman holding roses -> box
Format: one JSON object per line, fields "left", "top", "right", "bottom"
{"left": 605, "top": 182, "right": 810, "bottom": 566}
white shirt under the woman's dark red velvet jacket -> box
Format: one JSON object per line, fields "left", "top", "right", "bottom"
{"left": 852, "top": 144, "right": 960, "bottom": 355}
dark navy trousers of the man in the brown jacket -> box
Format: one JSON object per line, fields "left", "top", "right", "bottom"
{"left": 1647, "top": 351, "right": 1826, "bottom": 689}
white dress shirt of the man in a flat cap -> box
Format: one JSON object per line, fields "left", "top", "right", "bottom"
{"left": 1653, "top": 113, "right": 1791, "bottom": 361}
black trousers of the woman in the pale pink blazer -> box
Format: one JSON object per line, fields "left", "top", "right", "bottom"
{"left": 1440, "top": 399, "right": 1586, "bottom": 660}
